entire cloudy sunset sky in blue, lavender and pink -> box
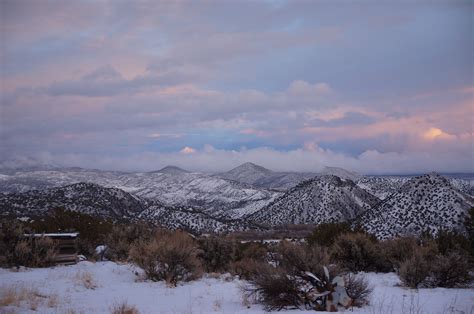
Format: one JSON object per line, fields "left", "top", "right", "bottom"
{"left": 0, "top": 0, "right": 474, "bottom": 174}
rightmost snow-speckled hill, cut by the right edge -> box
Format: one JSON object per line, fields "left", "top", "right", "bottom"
{"left": 357, "top": 173, "right": 474, "bottom": 239}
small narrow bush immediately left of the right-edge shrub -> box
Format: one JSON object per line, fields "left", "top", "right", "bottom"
{"left": 399, "top": 252, "right": 430, "bottom": 289}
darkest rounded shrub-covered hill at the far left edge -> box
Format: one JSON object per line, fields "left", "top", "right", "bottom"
{"left": 0, "top": 183, "right": 147, "bottom": 219}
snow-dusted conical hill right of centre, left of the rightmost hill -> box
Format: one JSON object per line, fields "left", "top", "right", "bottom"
{"left": 246, "top": 176, "right": 380, "bottom": 226}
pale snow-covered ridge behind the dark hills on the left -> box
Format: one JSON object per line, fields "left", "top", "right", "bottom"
{"left": 0, "top": 168, "right": 281, "bottom": 218}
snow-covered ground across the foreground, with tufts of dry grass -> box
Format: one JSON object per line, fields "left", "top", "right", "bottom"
{"left": 0, "top": 262, "right": 474, "bottom": 314}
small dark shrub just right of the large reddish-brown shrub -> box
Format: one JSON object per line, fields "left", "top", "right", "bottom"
{"left": 198, "top": 236, "right": 235, "bottom": 272}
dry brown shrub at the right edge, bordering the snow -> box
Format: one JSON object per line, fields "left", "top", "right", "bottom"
{"left": 430, "top": 252, "right": 471, "bottom": 288}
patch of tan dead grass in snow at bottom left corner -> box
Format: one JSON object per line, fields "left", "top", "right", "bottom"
{"left": 0, "top": 285, "right": 59, "bottom": 312}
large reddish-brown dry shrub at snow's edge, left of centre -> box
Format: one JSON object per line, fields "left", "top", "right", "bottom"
{"left": 130, "top": 231, "right": 201, "bottom": 286}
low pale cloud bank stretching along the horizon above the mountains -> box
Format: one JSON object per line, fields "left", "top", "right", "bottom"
{"left": 27, "top": 144, "right": 474, "bottom": 174}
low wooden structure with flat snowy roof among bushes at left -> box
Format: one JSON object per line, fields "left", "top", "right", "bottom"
{"left": 25, "top": 232, "right": 79, "bottom": 265}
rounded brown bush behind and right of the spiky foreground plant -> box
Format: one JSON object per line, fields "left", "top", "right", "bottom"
{"left": 330, "top": 233, "right": 383, "bottom": 272}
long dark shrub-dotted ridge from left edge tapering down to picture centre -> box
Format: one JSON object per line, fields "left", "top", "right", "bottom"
{"left": 0, "top": 183, "right": 258, "bottom": 233}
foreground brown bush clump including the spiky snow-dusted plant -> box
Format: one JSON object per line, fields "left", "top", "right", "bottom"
{"left": 244, "top": 241, "right": 362, "bottom": 310}
